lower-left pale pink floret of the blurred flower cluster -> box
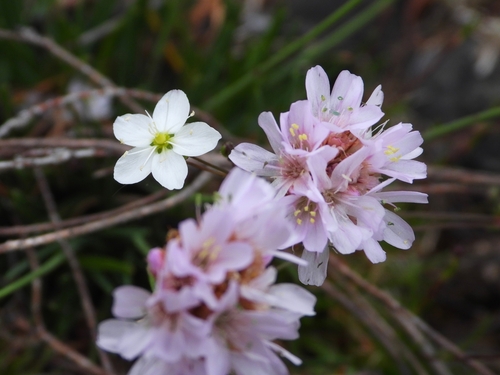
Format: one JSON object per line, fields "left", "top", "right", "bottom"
{"left": 97, "top": 286, "right": 210, "bottom": 363}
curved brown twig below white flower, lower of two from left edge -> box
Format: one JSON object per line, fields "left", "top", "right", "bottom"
{"left": 0, "top": 172, "right": 212, "bottom": 254}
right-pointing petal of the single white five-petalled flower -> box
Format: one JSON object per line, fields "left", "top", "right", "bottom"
{"left": 171, "top": 122, "right": 221, "bottom": 156}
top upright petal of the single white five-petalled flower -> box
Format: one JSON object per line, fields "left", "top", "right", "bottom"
{"left": 153, "top": 90, "right": 189, "bottom": 134}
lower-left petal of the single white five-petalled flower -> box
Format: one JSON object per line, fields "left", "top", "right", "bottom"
{"left": 113, "top": 146, "right": 155, "bottom": 184}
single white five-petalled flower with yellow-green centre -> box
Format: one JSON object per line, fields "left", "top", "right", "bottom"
{"left": 113, "top": 90, "right": 221, "bottom": 190}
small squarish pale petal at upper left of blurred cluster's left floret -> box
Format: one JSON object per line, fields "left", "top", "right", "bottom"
{"left": 111, "top": 285, "right": 151, "bottom": 319}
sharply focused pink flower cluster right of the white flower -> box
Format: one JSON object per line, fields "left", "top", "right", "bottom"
{"left": 229, "top": 66, "right": 427, "bottom": 285}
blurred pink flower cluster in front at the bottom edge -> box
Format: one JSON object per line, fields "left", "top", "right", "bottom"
{"left": 97, "top": 169, "right": 316, "bottom": 375}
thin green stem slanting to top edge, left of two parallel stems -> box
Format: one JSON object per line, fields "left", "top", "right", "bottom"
{"left": 203, "top": 0, "right": 361, "bottom": 111}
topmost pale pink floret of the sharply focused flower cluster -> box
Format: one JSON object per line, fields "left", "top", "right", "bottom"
{"left": 306, "top": 66, "right": 384, "bottom": 132}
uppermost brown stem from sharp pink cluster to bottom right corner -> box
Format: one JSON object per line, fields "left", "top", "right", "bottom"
{"left": 329, "top": 254, "right": 494, "bottom": 375}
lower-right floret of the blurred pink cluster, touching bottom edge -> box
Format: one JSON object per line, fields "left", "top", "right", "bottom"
{"left": 206, "top": 282, "right": 308, "bottom": 375}
